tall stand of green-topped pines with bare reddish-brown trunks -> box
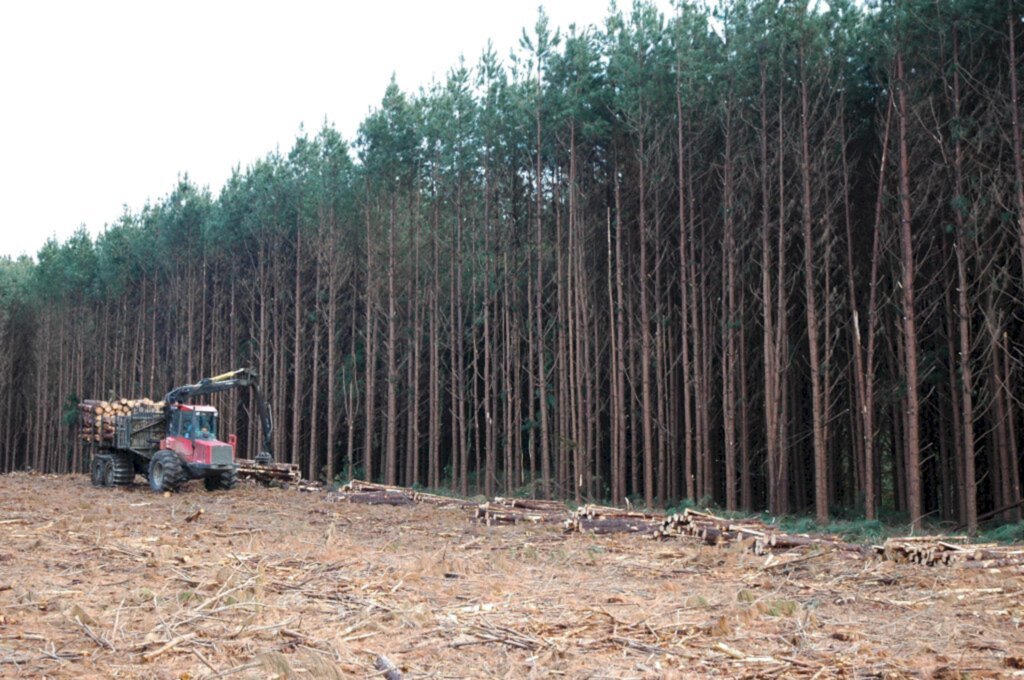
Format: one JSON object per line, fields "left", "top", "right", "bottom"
{"left": 0, "top": 0, "right": 1024, "bottom": 530}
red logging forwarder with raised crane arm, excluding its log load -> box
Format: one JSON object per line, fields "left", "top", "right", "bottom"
{"left": 86, "top": 369, "right": 299, "bottom": 492}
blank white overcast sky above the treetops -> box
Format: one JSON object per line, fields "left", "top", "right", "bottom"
{"left": 0, "top": 0, "right": 670, "bottom": 256}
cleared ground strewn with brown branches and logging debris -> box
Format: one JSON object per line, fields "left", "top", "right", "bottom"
{"left": 0, "top": 474, "right": 1024, "bottom": 678}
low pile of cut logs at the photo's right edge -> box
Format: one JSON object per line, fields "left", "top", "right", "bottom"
{"left": 874, "top": 536, "right": 1024, "bottom": 569}
